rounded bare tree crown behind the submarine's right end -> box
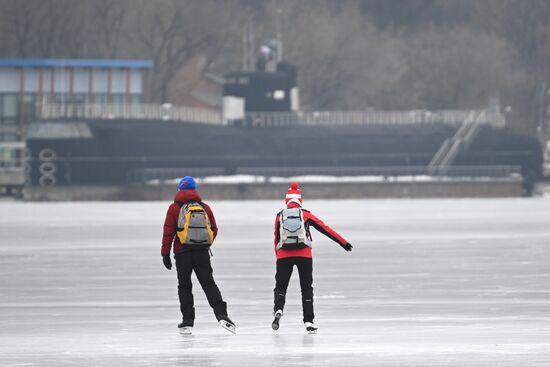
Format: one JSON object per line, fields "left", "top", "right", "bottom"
{"left": 397, "top": 28, "right": 526, "bottom": 109}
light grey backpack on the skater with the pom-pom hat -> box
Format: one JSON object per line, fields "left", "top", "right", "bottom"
{"left": 277, "top": 208, "right": 311, "bottom": 250}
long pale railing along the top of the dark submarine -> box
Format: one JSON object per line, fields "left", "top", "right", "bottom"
{"left": 36, "top": 102, "right": 505, "bottom": 127}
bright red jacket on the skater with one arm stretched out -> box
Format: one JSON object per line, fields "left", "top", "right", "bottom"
{"left": 274, "top": 203, "right": 348, "bottom": 259}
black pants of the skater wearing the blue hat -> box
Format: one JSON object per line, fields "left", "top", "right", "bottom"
{"left": 175, "top": 249, "right": 227, "bottom": 326}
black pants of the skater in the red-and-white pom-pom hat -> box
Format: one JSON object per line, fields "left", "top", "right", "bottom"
{"left": 273, "top": 257, "right": 315, "bottom": 322}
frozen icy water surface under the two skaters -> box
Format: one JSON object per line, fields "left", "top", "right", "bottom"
{"left": 0, "top": 198, "right": 550, "bottom": 367}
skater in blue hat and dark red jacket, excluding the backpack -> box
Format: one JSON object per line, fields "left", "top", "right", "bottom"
{"left": 161, "top": 176, "right": 235, "bottom": 334}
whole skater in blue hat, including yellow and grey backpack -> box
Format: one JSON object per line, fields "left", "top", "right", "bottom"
{"left": 161, "top": 176, "right": 235, "bottom": 334}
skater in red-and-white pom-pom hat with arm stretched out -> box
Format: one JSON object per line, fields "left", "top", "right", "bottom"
{"left": 271, "top": 183, "right": 353, "bottom": 334}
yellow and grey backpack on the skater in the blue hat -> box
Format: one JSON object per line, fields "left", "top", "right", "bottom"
{"left": 176, "top": 201, "right": 214, "bottom": 246}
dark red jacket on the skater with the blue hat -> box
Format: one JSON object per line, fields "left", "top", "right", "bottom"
{"left": 160, "top": 190, "right": 218, "bottom": 256}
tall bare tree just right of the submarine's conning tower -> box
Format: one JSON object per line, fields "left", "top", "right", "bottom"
{"left": 270, "top": 1, "right": 401, "bottom": 109}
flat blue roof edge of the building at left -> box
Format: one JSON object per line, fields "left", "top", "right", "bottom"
{"left": 0, "top": 59, "right": 153, "bottom": 69}
